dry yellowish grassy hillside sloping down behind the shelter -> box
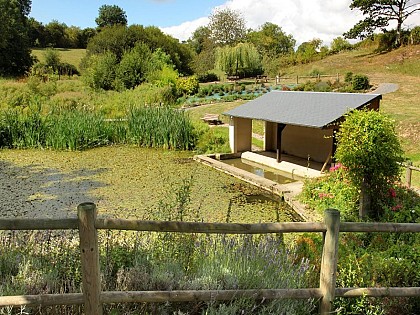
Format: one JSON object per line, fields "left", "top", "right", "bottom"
{"left": 192, "top": 45, "right": 420, "bottom": 187}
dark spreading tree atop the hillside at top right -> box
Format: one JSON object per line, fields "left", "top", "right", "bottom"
{"left": 344, "top": 0, "right": 420, "bottom": 47}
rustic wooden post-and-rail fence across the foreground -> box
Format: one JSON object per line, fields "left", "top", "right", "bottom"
{"left": 0, "top": 203, "right": 420, "bottom": 315}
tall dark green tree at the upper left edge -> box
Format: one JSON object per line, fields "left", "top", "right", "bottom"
{"left": 0, "top": 0, "right": 33, "bottom": 75}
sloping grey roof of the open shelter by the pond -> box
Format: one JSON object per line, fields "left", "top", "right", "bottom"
{"left": 224, "top": 91, "right": 382, "bottom": 128}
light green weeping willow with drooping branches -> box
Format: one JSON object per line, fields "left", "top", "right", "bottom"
{"left": 215, "top": 43, "right": 261, "bottom": 76}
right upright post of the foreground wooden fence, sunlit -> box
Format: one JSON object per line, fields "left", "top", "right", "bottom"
{"left": 319, "top": 209, "right": 340, "bottom": 315}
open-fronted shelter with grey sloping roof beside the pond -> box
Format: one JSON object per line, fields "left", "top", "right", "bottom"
{"left": 224, "top": 91, "right": 382, "bottom": 165}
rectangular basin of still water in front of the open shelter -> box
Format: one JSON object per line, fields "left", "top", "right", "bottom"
{"left": 223, "top": 158, "right": 296, "bottom": 184}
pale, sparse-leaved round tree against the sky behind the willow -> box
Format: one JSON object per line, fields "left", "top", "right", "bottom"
{"left": 208, "top": 8, "right": 246, "bottom": 46}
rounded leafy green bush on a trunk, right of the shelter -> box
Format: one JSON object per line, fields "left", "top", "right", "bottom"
{"left": 335, "top": 110, "right": 403, "bottom": 216}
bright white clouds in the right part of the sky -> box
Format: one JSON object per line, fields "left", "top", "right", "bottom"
{"left": 162, "top": 0, "right": 420, "bottom": 45}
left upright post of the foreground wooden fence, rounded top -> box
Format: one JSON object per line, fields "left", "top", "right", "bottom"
{"left": 77, "top": 202, "right": 103, "bottom": 315}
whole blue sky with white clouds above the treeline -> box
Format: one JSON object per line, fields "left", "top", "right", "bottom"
{"left": 30, "top": 0, "right": 420, "bottom": 45}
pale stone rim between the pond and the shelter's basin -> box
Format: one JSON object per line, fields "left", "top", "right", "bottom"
{"left": 194, "top": 154, "right": 322, "bottom": 222}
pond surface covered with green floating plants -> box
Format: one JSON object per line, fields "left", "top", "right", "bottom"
{"left": 0, "top": 146, "right": 297, "bottom": 223}
